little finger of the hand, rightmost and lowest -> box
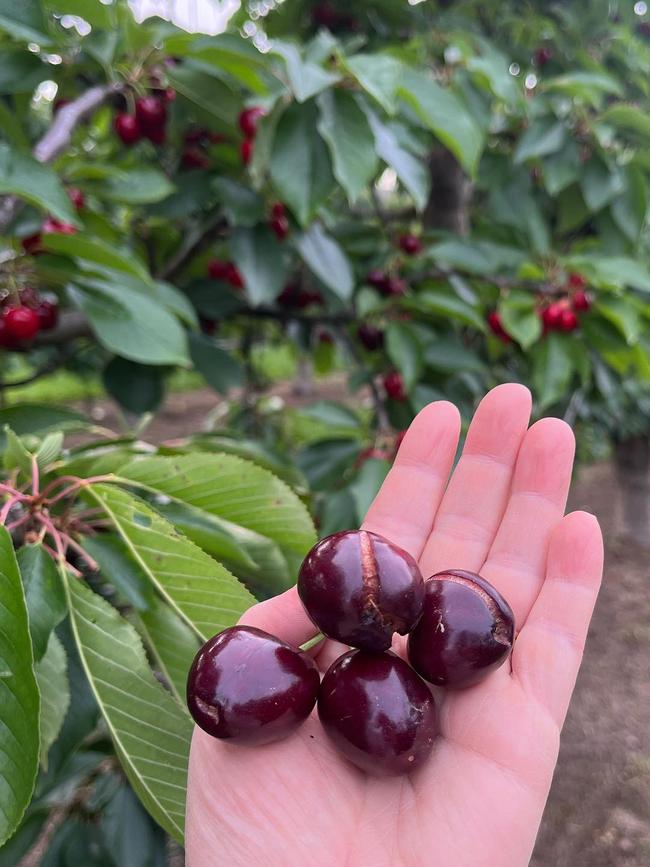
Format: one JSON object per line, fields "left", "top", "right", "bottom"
{"left": 512, "top": 512, "right": 603, "bottom": 728}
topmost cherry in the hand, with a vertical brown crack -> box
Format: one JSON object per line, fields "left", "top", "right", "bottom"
{"left": 298, "top": 530, "right": 424, "bottom": 651}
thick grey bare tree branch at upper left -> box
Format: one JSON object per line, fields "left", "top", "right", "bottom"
{"left": 0, "top": 84, "right": 119, "bottom": 233}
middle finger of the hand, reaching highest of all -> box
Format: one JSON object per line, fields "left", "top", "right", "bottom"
{"left": 420, "top": 383, "right": 531, "bottom": 577}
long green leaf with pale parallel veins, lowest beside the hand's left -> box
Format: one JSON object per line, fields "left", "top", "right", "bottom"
{"left": 65, "top": 576, "right": 192, "bottom": 842}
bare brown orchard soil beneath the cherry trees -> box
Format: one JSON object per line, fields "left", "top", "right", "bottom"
{"left": 68, "top": 381, "right": 650, "bottom": 867}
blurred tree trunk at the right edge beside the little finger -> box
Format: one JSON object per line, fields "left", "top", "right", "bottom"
{"left": 614, "top": 434, "right": 650, "bottom": 546}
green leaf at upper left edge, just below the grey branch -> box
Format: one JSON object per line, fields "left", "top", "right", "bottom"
{"left": 0, "top": 144, "right": 79, "bottom": 224}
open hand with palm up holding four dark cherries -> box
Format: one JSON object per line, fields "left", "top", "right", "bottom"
{"left": 187, "top": 385, "right": 602, "bottom": 867}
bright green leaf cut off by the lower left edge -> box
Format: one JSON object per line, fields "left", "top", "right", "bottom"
{"left": 0, "top": 527, "right": 39, "bottom": 846}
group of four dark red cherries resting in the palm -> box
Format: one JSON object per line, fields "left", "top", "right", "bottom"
{"left": 187, "top": 530, "right": 514, "bottom": 775}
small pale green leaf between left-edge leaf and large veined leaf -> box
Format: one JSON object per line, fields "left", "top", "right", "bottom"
{"left": 34, "top": 632, "right": 70, "bottom": 770}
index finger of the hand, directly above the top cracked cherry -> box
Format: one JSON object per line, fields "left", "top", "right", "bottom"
{"left": 363, "top": 401, "right": 460, "bottom": 559}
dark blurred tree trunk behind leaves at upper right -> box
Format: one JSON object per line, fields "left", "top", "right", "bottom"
{"left": 424, "top": 148, "right": 472, "bottom": 235}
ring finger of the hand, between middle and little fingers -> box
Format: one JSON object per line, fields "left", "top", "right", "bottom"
{"left": 480, "top": 418, "right": 575, "bottom": 626}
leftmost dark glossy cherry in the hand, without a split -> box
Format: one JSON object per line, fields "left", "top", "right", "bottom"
{"left": 187, "top": 626, "right": 320, "bottom": 746}
